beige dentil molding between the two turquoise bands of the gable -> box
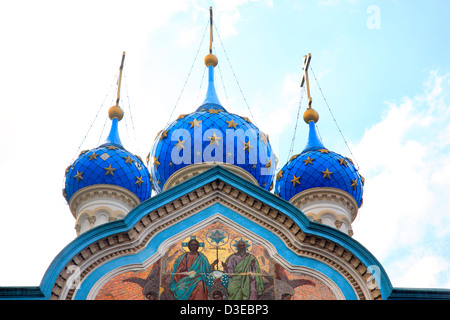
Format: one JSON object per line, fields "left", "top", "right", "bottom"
{"left": 50, "top": 179, "right": 382, "bottom": 300}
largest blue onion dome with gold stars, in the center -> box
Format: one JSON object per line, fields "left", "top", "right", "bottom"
{"left": 147, "top": 54, "right": 276, "bottom": 192}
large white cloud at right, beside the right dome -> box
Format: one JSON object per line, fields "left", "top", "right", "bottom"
{"left": 352, "top": 72, "right": 450, "bottom": 287}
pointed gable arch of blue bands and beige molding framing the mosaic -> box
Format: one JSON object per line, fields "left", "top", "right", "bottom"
{"left": 43, "top": 167, "right": 392, "bottom": 299}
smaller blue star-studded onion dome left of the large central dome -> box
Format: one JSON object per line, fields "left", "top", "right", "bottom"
{"left": 63, "top": 106, "right": 152, "bottom": 203}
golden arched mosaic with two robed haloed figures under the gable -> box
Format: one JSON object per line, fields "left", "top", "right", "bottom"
{"left": 96, "top": 222, "right": 335, "bottom": 300}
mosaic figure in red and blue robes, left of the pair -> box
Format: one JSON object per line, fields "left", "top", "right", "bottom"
{"left": 170, "top": 239, "right": 218, "bottom": 300}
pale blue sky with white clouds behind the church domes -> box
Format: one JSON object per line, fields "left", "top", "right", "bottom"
{"left": 0, "top": 0, "right": 450, "bottom": 288}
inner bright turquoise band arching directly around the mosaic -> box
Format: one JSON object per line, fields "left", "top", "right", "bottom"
{"left": 75, "top": 203, "right": 357, "bottom": 300}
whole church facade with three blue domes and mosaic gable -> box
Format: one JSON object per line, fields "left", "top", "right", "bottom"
{"left": 0, "top": 10, "right": 450, "bottom": 301}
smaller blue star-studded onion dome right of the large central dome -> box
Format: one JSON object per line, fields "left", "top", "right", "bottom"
{"left": 275, "top": 108, "right": 364, "bottom": 207}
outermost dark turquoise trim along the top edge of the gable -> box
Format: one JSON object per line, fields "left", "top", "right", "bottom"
{"left": 25, "top": 166, "right": 393, "bottom": 299}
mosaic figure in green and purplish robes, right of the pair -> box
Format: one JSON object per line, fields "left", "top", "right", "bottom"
{"left": 222, "top": 239, "right": 264, "bottom": 300}
